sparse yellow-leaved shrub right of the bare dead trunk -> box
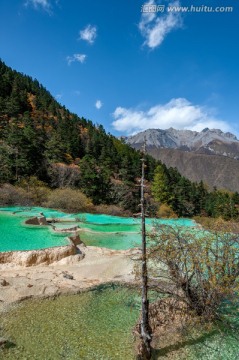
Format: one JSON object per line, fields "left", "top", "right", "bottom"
{"left": 148, "top": 220, "right": 239, "bottom": 319}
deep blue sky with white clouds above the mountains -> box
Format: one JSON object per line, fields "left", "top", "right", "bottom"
{"left": 0, "top": 0, "right": 239, "bottom": 136}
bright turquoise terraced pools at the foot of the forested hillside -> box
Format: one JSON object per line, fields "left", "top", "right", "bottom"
{"left": 0, "top": 207, "right": 195, "bottom": 251}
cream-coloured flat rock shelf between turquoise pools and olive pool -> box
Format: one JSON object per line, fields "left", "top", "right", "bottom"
{"left": 0, "top": 245, "right": 140, "bottom": 311}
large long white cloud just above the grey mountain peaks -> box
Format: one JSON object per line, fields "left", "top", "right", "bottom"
{"left": 112, "top": 98, "right": 231, "bottom": 135}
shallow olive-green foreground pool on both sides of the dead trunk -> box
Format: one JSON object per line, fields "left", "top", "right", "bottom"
{"left": 0, "top": 285, "right": 239, "bottom": 360}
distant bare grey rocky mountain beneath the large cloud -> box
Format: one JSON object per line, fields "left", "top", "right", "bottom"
{"left": 126, "top": 128, "right": 239, "bottom": 191}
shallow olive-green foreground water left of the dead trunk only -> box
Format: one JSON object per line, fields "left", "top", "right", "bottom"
{"left": 0, "top": 287, "right": 140, "bottom": 360}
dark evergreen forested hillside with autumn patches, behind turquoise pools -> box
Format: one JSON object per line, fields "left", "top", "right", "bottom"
{"left": 0, "top": 61, "right": 238, "bottom": 218}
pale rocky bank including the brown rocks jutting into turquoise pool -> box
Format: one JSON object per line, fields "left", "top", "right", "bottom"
{"left": 0, "top": 213, "right": 141, "bottom": 311}
